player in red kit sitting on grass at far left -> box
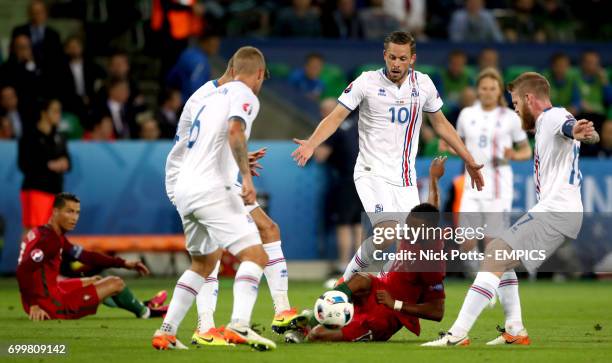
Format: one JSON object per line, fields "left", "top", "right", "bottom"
{"left": 17, "top": 193, "right": 166, "bottom": 321}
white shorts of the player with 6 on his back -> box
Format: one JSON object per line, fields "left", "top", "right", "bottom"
{"left": 177, "top": 187, "right": 261, "bottom": 256}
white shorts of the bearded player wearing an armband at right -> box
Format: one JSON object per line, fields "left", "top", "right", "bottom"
{"left": 500, "top": 212, "right": 571, "bottom": 273}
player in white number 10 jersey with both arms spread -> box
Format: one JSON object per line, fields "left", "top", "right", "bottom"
{"left": 292, "top": 31, "right": 483, "bottom": 281}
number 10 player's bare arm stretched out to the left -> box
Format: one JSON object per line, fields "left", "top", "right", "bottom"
{"left": 291, "top": 105, "right": 350, "bottom": 166}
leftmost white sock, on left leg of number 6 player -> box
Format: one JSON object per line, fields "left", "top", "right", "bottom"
{"left": 160, "top": 270, "right": 205, "bottom": 335}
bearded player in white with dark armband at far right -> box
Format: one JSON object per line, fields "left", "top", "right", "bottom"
{"left": 423, "top": 72, "right": 599, "bottom": 346}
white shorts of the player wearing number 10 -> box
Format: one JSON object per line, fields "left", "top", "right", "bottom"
{"left": 355, "top": 175, "right": 421, "bottom": 226}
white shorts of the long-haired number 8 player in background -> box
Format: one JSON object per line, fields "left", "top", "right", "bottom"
{"left": 459, "top": 193, "right": 512, "bottom": 238}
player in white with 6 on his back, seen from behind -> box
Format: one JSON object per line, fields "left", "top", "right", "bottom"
{"left": 152, "top": 47, "right": 276, "bottom": 350}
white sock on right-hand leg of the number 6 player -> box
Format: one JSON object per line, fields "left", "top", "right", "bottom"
{"left": 231, "top": 261, "right": 263, "bottom": 327}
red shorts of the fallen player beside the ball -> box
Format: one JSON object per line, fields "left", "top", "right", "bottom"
{"left": 342, "top": 276, "right": 403, "bottom": 342}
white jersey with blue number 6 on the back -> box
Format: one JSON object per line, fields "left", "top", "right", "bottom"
{"left": 174, "top": 81, "right": 259, "bottom": 206}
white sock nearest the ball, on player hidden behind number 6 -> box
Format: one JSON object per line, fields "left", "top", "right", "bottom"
{"left": 263, "top": 241, "right": 291, "bottom": 314}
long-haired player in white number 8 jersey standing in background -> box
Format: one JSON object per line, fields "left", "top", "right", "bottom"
{"left": 457, "top": 68, "right": 531, "bottom": 264}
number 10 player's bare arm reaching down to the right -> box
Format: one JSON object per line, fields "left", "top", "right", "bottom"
{"left": 429, "top": 111, "right": 484, "bottom": 190}
